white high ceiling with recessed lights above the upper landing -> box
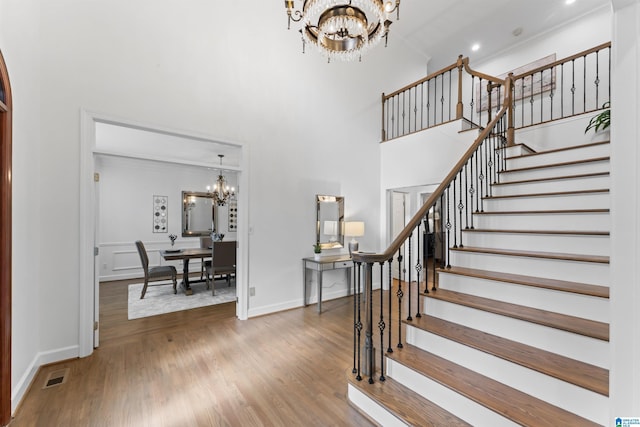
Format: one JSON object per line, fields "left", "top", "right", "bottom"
{"left": 396, "top": 0, "right": 610, "bottom": 71}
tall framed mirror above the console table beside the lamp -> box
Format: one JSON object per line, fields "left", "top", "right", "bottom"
{"left": 316, "top": 194, "right": 344, "bottom": 249}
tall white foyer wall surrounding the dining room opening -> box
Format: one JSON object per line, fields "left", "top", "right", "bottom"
{"left": 0, "top": 0, "right": 424, "bottom": 414}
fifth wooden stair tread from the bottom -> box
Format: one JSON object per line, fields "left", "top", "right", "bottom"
{"left": 438, "top": 266, "right": 609, "bottom": 298}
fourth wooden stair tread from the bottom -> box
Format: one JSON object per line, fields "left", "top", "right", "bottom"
{"left": 423, "top": 289, "right": 609, "bottom": 341}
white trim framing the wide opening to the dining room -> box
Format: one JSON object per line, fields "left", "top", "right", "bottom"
{"left": 78, "top": 109, "right": 249, "bottom": 357}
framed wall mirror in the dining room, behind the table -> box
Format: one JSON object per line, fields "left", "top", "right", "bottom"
{"left": 182, "top": 191, "right": 215, "bottom": 237}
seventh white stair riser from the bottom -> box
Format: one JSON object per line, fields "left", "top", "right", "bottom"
{"left": 458, "top": 232, "right": 610, "bottom": 256}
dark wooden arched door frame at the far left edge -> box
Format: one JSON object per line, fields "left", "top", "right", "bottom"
{"left": 0, "top": 48, "right": 12, "bottom": 426}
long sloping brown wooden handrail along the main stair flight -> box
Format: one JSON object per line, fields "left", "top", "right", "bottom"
{"left": 352, "top": 79, "right": 511, "bottom": 263}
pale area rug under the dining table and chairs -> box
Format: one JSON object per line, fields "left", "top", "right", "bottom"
{"left": 128, "top": 282, "right": 236, "bottom": 320}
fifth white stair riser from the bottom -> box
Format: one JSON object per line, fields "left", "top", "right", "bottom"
{"left": 438, "top": 273, "right": 609, "bottom": 322}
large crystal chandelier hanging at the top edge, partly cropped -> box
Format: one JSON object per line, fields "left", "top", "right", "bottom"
{"left": 284, "top": 0, "right": 400, "bottom": 61}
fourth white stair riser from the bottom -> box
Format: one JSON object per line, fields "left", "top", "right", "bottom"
{"left": 423, "top": 298, "right": 609, "bottom": 369}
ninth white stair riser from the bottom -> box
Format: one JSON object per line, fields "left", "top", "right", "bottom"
{"left": 482, "top": 192, "right": 611, "bottom": 212}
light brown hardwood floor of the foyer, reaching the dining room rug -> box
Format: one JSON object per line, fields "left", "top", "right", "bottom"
{"left": 10, "top": 281, "right": 372, "bottom": 427}
